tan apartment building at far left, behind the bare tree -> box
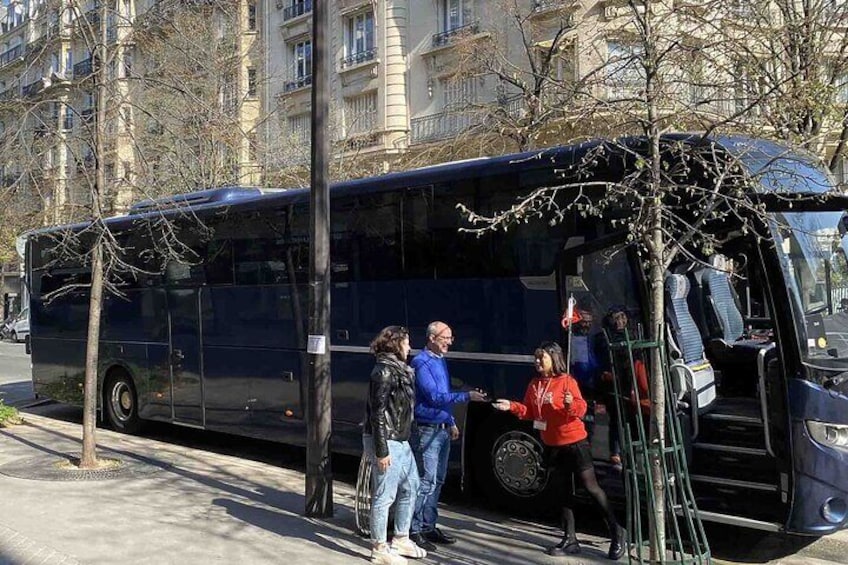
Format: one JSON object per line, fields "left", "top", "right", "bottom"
{"left": 0, "top": 0, "right": 260, "bottom": 222}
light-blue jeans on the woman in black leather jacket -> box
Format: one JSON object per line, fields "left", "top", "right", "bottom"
{"left": 362, "top": 435, "right": 419, "bottom": 545}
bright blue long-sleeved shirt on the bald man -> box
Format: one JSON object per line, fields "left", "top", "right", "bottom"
{"left": 411, "top": 348, "right": 469, "bottom": 426}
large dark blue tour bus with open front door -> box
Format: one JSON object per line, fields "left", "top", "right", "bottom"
{"left": 26, "top": 137, "right": 848, "bottom": 535}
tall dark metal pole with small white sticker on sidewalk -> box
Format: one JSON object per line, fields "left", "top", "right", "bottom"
{"left": 306, "top": 0, "right": 333, "bottom": 518}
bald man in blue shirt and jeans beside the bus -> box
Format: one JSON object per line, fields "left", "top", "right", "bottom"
{"left": 409, "top": 322, "right": 486, "bottom": 551}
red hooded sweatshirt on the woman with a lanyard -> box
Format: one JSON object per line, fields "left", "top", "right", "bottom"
{"left": 509, "top": 374, "right": 588, "bottom": 446}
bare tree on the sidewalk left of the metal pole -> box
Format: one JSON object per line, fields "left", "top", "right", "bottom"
{"left": 0, "top": 0, "right": 259, "bottom": 468}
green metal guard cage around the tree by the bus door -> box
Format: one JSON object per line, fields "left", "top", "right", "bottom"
{"left": 606, "top": 331, "right": 711, "bottom": 565}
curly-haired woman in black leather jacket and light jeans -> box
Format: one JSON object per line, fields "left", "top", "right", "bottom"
{"left": 362, "top": 326, "right": 427, "bottom": 565}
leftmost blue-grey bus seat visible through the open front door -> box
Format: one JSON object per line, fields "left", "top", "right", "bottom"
{"left": 665, "top": 274, "right": 716, "bottom": 430}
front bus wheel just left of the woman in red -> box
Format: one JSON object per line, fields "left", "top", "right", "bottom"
{"left": 474, "top": 414, "right": 559, "bottom": 514}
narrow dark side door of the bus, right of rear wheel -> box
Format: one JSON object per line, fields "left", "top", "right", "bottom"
{"left": 168, "top": 288, "right": 205, "bottom": 427}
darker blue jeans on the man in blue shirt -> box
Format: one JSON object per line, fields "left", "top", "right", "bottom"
{"left": 409, "top": 425, "right": 450, "bottom": 534}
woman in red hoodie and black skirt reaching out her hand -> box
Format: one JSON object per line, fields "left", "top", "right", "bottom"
{"left": 492, "top": 342, "right": 625, "bottom": 560}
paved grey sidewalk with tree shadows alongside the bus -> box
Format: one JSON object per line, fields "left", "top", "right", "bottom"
{"left": 0, "top": 414, "right": 609, "bottom": 565}
